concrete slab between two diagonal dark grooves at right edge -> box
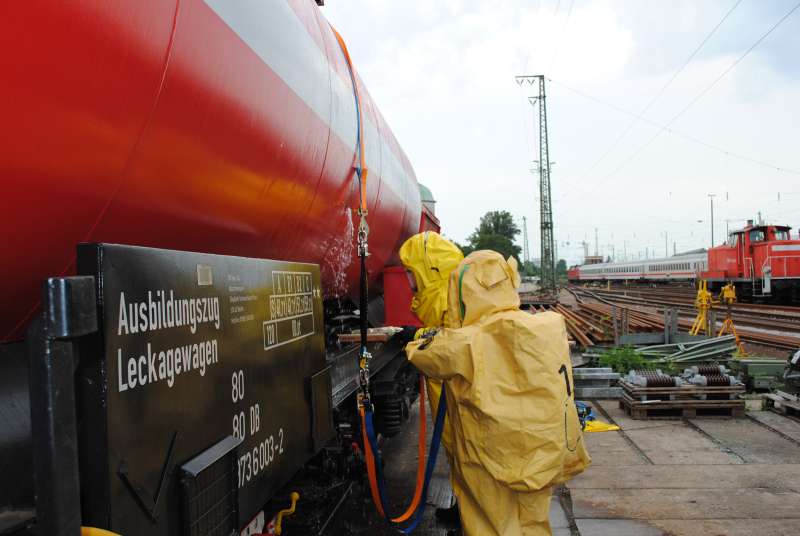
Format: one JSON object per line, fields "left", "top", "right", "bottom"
{"left": 691, "top": 419, "right": 800, "bottom": 464}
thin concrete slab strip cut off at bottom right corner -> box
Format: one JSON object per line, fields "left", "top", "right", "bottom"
{"left": 652, "top": 519, "right": 798, "bottom": 536}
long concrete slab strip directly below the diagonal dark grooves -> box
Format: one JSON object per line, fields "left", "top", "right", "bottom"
{"left": 569, "top": 464, "right": 800, "bottom": 493}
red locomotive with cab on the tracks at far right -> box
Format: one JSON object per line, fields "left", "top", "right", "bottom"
{"left": 701, "top": 221, "right": 800, "bottom": 302}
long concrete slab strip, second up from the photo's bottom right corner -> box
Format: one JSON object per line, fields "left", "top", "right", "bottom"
{"left": 571, "top": 488, "right": 800, "bottom": 520}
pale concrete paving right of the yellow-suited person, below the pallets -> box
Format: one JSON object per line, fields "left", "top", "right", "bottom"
{"left": 568, "top": 401, "right": 800, "bottom": 536}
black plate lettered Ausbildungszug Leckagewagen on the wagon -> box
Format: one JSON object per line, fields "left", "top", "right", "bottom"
{"left": 78, "top": 244, "right": 331, "bottom": 535}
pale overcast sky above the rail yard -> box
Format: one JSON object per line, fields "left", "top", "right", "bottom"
{"left": 322, "top": 0, "right": 800, "bottom": 264}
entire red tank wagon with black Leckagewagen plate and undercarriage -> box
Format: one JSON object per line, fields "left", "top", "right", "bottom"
{"left": 0, "top": 0, "right": 439, "bottom": 535}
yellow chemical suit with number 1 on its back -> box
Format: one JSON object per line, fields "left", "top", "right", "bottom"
{"left": 406, "top": 251, "right": 590, "bottom": 536}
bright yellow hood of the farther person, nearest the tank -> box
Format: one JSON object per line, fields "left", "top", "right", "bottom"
{"left": 400, "top": 231, "right": 464, "bottom": 327}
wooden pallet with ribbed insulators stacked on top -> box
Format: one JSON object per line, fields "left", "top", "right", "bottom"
{"left": 619, "top": 393, "right": 745, "bottom": 419}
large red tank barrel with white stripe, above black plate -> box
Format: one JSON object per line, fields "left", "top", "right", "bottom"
{"left": 0, "top": 0, "right": 427, "bottom": 341}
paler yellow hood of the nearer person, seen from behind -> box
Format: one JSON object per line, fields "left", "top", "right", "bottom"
{"left": 445, "top": 250, "right": 520, "bottom": 328}
